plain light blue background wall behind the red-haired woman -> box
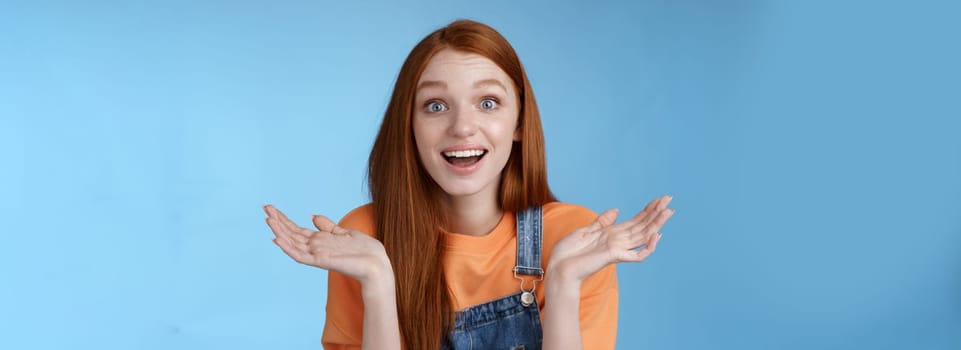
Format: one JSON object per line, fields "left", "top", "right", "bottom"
{"left": 0, "top": 1, "right": 961, "bottom": 349}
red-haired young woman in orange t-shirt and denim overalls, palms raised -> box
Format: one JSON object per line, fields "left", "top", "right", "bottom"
{"left": 264, "top": 20, "right": 674, "bottom": 349}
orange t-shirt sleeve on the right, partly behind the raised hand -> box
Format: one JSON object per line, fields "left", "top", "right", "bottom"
{"left": 543, "top": 203, "right": 618, "bottom": 349}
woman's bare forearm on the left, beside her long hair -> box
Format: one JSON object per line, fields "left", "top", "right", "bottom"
{"left": 361, "top": 273, "right": 400, "bottom": 350}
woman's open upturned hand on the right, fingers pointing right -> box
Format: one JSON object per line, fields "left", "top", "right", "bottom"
{"left": 547, "top": 196, "right": 674, "bottom": 282}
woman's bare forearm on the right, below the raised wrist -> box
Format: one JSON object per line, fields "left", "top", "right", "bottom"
{"left": 543, "top": 268, "right": 583, "bottom": 350}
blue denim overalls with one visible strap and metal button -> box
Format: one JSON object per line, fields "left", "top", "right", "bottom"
{"left": 443, "top": 207, "right": 544, "bottom": 350}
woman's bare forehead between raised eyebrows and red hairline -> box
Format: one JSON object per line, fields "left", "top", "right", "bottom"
{"left": 418, "top": 49, "right": 512, "bottom": 86}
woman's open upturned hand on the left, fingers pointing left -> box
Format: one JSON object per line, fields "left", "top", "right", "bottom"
{"left": 264, "top": 205, "right": 393, "bottom": 285}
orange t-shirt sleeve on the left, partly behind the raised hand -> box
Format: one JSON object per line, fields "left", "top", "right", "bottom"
{"left": 321, "top": 204, "right": 374, "bottom": 350}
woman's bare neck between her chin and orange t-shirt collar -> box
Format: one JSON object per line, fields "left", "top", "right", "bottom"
{"left": 447, "top": 191, "right": 504, "bottom": 236}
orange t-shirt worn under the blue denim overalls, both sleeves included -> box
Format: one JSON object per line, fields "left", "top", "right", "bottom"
{"left": 322, "top": 202, "right": 618, "bottom": 349}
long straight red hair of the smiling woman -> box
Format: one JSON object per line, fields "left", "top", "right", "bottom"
{"left": 368, "top": 20, "right": 555, "bottom": 349}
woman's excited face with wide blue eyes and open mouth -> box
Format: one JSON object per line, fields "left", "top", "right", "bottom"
{"left": 414, "top": 49, "right": 520, "bottom": 199}
